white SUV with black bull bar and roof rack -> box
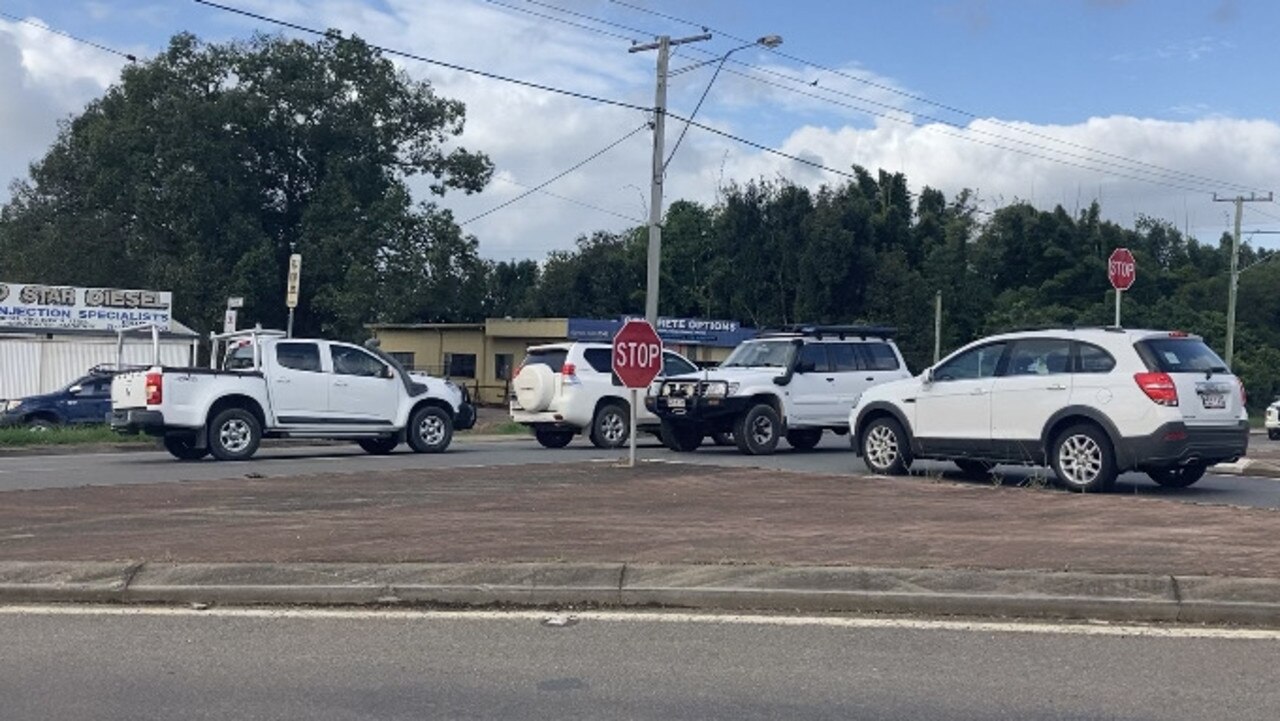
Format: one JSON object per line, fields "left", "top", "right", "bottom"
{"left": 645, "top": 325, "right": 911, "bottom": 455}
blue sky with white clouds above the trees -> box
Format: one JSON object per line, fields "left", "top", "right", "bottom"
{"left": 0, "top": 0, "right": 1280, "bottom": 259}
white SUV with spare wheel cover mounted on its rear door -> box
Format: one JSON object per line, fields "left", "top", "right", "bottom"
{"left": 511, "top": 342, "right": 698, "bottom": 448}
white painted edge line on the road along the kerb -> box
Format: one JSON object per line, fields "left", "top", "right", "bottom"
{"left": 0, "top": 604, "right": 1280, "bottom": 640}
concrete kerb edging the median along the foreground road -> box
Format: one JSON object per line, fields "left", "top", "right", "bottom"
{"left": 0, "top": 562, "right": 1280, "bottom": 626}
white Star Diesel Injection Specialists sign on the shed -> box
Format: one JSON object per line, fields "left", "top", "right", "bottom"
{"left": 0, "top": 283, "right": 173, "bottom": 330}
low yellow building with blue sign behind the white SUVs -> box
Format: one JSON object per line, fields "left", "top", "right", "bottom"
{"left": 369, "top": 318, "right": 755, "bottom": 405}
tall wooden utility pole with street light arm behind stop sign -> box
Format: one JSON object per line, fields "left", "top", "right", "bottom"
{"left": 627, "top": 33, "right": 782, "bottom": 327}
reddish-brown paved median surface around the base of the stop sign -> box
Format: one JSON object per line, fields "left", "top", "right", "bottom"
{"left": 0, "top": 464, "right": 1280, "bottom": 576}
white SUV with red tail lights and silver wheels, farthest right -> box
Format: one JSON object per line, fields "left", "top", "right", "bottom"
{"left": 850, "top": 328, "right": 1249, "bottom": 490}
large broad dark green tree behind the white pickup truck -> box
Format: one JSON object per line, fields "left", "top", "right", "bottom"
{"left": 0, "top": 33, "right": 492, "bottom": 338}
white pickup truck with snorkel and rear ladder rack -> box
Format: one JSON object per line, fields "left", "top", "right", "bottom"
{"left": 110, "top": 329, "right": 475, "bottom": 461}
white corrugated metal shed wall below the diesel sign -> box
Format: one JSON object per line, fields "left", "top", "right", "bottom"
{"left": 0, "top": 324, "right": 197, "bottom": 398}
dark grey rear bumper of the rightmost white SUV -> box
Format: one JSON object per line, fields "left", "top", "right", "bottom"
{"left": 1116, "top": 421, "right": 1249, "bottom": 469}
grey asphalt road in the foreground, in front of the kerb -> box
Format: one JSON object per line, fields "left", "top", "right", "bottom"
{"left": 0, "top": 607, "right": 1280, "bottom": 721}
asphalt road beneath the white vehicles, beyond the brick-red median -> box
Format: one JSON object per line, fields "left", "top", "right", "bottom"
{"left": 0, "top": 434, "right": 1280, "bottom": 508}
